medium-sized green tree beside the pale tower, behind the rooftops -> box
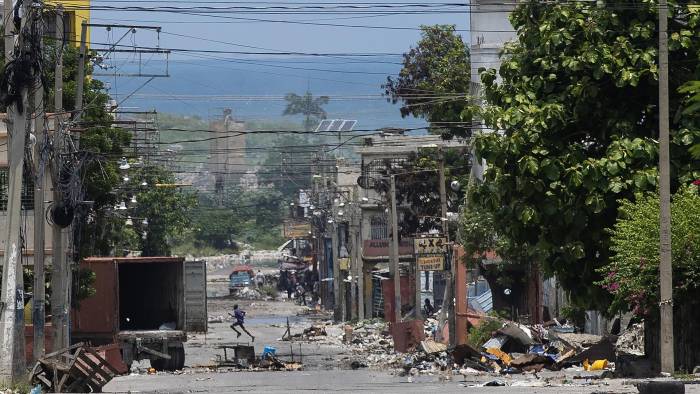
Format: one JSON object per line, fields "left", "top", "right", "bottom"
{"left": 382, "top": 25, "right": 471, "bottom": 139}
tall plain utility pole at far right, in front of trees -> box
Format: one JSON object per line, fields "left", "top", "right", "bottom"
{"left": 659, "top": 0, "right": 675, "bottom": 373}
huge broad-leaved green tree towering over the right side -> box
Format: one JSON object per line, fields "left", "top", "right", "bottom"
{"left": 466, "top": 1, "right": 700, "bottom": 307}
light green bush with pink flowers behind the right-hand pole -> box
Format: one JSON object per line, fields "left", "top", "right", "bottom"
{"left": 598, "top": 186, "right": 700, "bottom": 316}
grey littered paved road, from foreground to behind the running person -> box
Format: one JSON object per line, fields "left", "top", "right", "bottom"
{"left": 104, "top": 288, "right": 700, "bottom": 394}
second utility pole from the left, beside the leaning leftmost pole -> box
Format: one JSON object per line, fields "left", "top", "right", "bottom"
{"left": 32, "top": 19, "right": 46, "bottom": 360}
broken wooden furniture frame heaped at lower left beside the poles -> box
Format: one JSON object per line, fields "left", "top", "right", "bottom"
{"left": 30, "top": 343, "right": 119, "bottom": 393}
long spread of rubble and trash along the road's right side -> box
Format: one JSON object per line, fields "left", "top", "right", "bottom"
{"left": 292, "top": 319, "right": 643, "bottom": 378}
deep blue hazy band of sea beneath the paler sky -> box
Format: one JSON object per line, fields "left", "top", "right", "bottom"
{"left": 96, "top": 57, "right": 425, "bottom": 130}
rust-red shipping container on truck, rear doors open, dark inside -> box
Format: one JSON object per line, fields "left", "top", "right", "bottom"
{"left": 71, "top": 257, "right": 207, "bottom": 369}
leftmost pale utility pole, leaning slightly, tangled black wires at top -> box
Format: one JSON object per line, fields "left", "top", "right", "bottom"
{"left": 0, "top": 0, "right": 33, "bottom": 384}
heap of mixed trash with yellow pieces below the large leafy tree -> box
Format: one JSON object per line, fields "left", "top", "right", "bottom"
{"left": 388, "top": 321, "right": 624, "bottom": 378}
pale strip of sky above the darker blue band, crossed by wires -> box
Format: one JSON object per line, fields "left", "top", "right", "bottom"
{"left": 92, "top": 0, "right": 469, "bottom": 57}
